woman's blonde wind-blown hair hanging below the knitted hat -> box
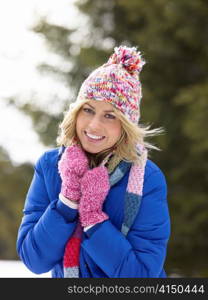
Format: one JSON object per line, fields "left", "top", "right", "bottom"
{"left": 56, "top": 99, "right": 164, "bottom": 167}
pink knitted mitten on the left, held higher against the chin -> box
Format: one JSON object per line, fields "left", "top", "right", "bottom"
{"left": 58, "top": 145, "right": 89, "bottom": 201}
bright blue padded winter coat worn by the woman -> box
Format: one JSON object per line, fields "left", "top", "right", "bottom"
{"left": 17, "top": 147, "right": 170, "bottom": 278}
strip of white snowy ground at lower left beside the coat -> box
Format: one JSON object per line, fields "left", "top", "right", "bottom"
{"left": 0, "top": 260, "right": 51, "bottom": 278}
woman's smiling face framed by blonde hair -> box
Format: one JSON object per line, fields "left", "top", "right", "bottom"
{"left": 76, "top": 100, "right": 122, "bottom": 153}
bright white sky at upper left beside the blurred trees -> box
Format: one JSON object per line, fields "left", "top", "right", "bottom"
{"left": 0, "top": 0, "right": 79, "bottom": 165}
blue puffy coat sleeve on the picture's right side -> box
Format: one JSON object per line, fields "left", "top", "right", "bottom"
{"left": 83, "top": 170, "right": 170, "bottom": 278}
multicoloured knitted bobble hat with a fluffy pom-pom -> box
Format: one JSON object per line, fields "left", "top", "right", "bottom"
{"left": 76, "top": 46, "right": 145, "bottom": 123}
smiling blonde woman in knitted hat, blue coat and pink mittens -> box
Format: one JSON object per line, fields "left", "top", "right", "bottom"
{"left": 17, "top": 46, "right": 170, "bottom": 278}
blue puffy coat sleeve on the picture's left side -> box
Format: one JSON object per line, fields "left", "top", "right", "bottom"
{"left": 16, "top": 153, "right": 78, "bottom": 274}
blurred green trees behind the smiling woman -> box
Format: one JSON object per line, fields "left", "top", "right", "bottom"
{"left": 0, "top": 0, "right": 208, "bottom": 277}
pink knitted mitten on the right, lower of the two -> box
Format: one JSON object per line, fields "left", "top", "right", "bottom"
{"left": 79, "top": 166, "right": 110, "bottom": 227}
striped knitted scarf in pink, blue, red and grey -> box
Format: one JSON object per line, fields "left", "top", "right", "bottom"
{"left": 63, "top": 144, "right": 147, "bottom": 278}
